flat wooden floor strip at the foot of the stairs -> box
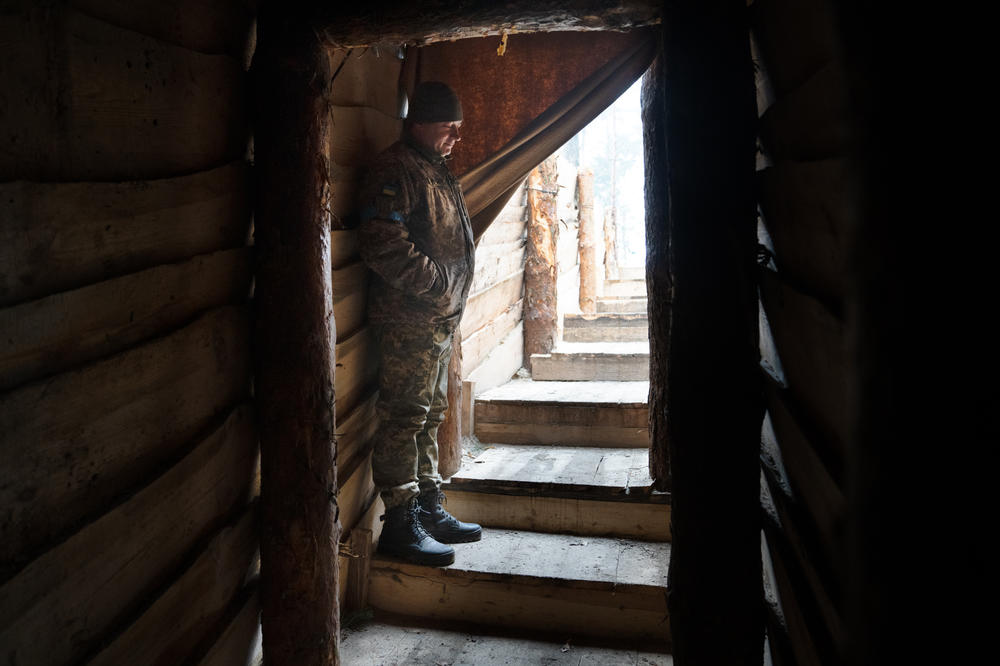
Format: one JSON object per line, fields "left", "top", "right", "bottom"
{"left": 340, "top": 613, "right": 673, "bottom": 666}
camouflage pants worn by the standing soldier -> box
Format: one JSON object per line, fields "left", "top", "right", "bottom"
{"left": 372, "top": 324, "right": 451, "bottom": 509}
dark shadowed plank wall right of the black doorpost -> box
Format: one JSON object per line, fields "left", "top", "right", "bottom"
{"left": 752, "top": 0, "right": 850, "bottom": 665}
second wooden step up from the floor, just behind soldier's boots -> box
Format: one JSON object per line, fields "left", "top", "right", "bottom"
{"left": 443, "top": 444, "right": 670, "bottom": 541}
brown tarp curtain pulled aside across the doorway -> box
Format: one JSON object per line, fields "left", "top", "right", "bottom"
{"left": 417, "top": 30, "right": 657, "bottom": 240}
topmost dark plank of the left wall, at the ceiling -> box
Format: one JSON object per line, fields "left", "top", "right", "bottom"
{"left": 69, "top": 0, "right": 253, "bottom": 57}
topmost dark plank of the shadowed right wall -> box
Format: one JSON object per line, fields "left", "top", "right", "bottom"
{"left": 750, "top": 0, "right": 840, "bottom": 94}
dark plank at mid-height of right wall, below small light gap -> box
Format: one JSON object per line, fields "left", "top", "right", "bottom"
{"left": 760, "top": 270, "right": 848, "bottom": 460}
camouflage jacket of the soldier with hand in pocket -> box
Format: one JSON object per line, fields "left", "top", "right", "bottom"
{"left": 358, "top": 137, "right": 475, "bottom": 329}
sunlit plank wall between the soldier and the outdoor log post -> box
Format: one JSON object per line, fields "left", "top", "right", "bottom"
{"left": 461, "top": 179, "right": 528, "bottom": 392}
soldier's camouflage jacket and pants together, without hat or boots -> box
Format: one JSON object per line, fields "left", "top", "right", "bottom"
{"left": 358, "top": 137, "right": 475, "bottom": 509}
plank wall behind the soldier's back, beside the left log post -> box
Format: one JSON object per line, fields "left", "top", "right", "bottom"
{"left": 328, "top": 47, "right": 404, "bottom": 617}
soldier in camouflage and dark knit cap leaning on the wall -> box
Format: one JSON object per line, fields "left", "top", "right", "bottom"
{"left": 358, "top": 81, "right": 482, "bottom": 566}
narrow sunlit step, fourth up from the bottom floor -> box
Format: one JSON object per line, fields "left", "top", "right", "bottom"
{"left": 531, "top": 340, "right": 649, "bottom": 381}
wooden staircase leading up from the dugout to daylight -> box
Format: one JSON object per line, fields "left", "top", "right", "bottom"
{"left": 352, "top": 272, "right": 670, "bottom": 663}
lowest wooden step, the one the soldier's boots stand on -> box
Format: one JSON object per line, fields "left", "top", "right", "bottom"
{"left": 368, "top": 529, "right": 670, "bottom": 645}
